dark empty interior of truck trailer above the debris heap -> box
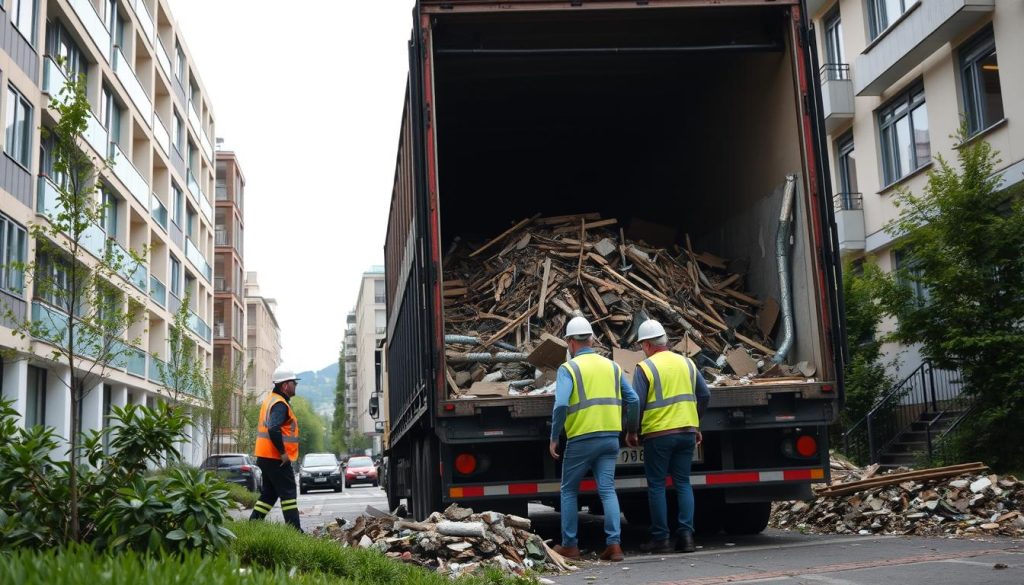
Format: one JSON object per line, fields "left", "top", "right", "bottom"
{"left": 432, "top": 6, "right": 822, "bottom": 365}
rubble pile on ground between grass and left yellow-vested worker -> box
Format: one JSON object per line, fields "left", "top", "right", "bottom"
{"left": 317, "top": 504, "right": 572, "bottom": 577}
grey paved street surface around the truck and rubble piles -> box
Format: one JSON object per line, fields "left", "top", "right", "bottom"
{"left": 245, "top": 486, "right": 1024, "bottom": 585}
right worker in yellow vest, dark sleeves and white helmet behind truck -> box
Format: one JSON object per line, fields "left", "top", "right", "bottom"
{"left": 626, "top": 319, "right": 711, "bottom": 554}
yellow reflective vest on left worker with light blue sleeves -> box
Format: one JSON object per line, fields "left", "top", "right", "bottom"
{"left": 561, "top": 353, "right": 623, "bottom": 438}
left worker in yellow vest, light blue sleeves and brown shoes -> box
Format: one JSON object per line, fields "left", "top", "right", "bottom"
{"left": 550, "top": 317, "right": 639, "bottom": 561}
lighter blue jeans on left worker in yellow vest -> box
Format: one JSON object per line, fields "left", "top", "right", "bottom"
{"left": 562, "top": 436, "right": 622, "bottom": 546}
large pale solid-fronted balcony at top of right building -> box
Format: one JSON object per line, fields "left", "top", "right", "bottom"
{"left": 854, "top": 0, "right": 995, "bottom": 95}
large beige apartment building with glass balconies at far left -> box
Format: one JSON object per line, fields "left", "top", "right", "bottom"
{"left": 0, "top": 0, "right": 215, "bottom": 462}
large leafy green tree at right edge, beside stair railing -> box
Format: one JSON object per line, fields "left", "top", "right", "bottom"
{"left": 881, "top": 130, "right": 1024, "bottom": 468}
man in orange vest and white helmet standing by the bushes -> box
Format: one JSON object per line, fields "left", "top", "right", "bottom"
{"left": 249, "top": 370, "right": 302, "bottom": 532}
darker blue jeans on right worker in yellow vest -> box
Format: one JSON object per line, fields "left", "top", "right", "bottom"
{"left": 643, "top": 432, "right": 697, "bottom": 540}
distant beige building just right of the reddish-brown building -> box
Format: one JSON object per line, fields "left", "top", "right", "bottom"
{"left": 245, "top": 271, "right": 281, "bottom": 400}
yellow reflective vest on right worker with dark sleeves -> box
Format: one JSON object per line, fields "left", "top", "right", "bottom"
{"left": 638, "top": 351, "right": 700, "bottom": 434}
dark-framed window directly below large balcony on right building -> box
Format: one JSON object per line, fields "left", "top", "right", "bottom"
{"left": 879, "top": 84, "right": 932, "bottom": 184}
